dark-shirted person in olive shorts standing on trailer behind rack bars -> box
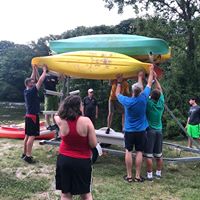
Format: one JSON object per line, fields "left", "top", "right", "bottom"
{"left": 44, "top": 74, "right": 59, "bottom": 130}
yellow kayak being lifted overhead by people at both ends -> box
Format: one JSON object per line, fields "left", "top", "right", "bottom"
{"left": 32, "top": 51, "right": 150, "bottom": 80}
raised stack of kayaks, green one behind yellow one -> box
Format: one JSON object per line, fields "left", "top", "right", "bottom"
{"left": 32, "top": 34, "right": 171, "bottom": 80}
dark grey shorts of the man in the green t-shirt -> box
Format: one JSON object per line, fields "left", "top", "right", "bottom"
{"left": 144, "top": 128, "right": 163, "bottom": 158}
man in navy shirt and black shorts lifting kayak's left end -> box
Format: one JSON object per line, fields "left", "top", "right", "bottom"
{"left": 21, "top": 65, "right": 47, "bottom": 164}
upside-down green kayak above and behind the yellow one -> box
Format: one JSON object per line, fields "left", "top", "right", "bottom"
{"left": 50, "top": 34, "right": 169, "bottom": 56}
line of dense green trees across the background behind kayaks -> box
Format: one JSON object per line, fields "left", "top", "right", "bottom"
{"left": 0, "top": 0, "right": 200, "bottom": 136}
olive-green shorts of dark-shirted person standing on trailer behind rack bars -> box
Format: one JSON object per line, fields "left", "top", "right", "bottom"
{"left": 44, "top": 96, "right": 58, "bottom": 111}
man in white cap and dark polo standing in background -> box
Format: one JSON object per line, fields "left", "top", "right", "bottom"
{"left": 83, "top": 88, "right": 98, "bottom": 125}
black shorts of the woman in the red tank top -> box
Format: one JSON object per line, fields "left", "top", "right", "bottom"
{"left": 56, "top": 154, "right": 92, "bottom": 195}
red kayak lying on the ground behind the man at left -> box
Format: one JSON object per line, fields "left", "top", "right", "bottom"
{"left": 0, "top": 122, "right": 55, "bottom": 140}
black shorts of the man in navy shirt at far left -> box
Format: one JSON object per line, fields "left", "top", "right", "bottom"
{"left": 25, "top": 115, "right": 40, "bottom": 136}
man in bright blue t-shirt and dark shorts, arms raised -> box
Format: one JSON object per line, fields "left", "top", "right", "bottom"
{"left": 116, "top": 65, "right": 154, "bottom": 183}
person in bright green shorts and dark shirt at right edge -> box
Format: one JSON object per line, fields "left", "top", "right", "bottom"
{"left": 186, "top": 97, "right": 200, "bottom": 148}
